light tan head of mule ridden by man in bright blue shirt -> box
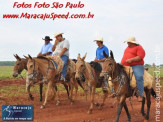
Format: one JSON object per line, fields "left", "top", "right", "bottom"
{"left": 75, "top": 54, "right": 87, "bottom": 80}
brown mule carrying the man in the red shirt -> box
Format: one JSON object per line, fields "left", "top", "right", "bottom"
{"left": 100, "top": 51, "right": 156, "bottom": 122}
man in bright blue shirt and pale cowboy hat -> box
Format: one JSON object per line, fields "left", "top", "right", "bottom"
{"left": 94, "top": 37, "right": 109, "bottom": 90}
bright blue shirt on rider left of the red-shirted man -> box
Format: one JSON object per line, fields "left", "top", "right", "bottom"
{"left": 96, "top": 45, "right": 109, "bottom": 59}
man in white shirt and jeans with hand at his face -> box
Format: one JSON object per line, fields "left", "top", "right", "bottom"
{"left": 52, "top": 32, "right": 70, "bottom": 81}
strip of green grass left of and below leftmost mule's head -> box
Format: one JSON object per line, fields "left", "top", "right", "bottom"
{"left": 0, "top": 66, "right": 26, "bottom": 80}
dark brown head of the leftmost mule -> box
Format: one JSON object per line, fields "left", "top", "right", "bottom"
{"left": 12, "top": 54, "right": 27, "bottom": 77}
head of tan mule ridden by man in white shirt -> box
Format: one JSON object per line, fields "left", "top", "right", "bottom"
{"left": 24, "top": 55, "right": 39, "bottom": 80}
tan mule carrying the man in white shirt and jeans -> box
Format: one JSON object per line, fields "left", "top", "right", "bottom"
{"left": 26, "top": 55, "right": 77, "bottom": 109}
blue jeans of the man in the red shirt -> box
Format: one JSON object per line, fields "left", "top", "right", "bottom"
{"left": 132, "top": 65, "right": 144, "bottom": 97}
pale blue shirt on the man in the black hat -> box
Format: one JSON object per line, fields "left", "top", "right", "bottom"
{"left": 40, "top": 42, "right": 53, "bottom": 56}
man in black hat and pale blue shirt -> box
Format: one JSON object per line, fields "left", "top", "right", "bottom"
{"left": 37, "top": 36, "right": 53, "bottom": 56}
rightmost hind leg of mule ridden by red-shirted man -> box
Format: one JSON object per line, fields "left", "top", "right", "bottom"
{"left": 145, "top": 88, "right": 151, "bottom": 120}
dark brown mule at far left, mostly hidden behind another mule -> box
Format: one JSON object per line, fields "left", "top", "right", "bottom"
{"left": 13, "top": 54, "right": 43, "bottom": 101}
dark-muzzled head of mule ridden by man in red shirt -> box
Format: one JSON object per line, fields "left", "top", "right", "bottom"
{"left": 100, "top": 51, "right": 116, "bottom": 77}
